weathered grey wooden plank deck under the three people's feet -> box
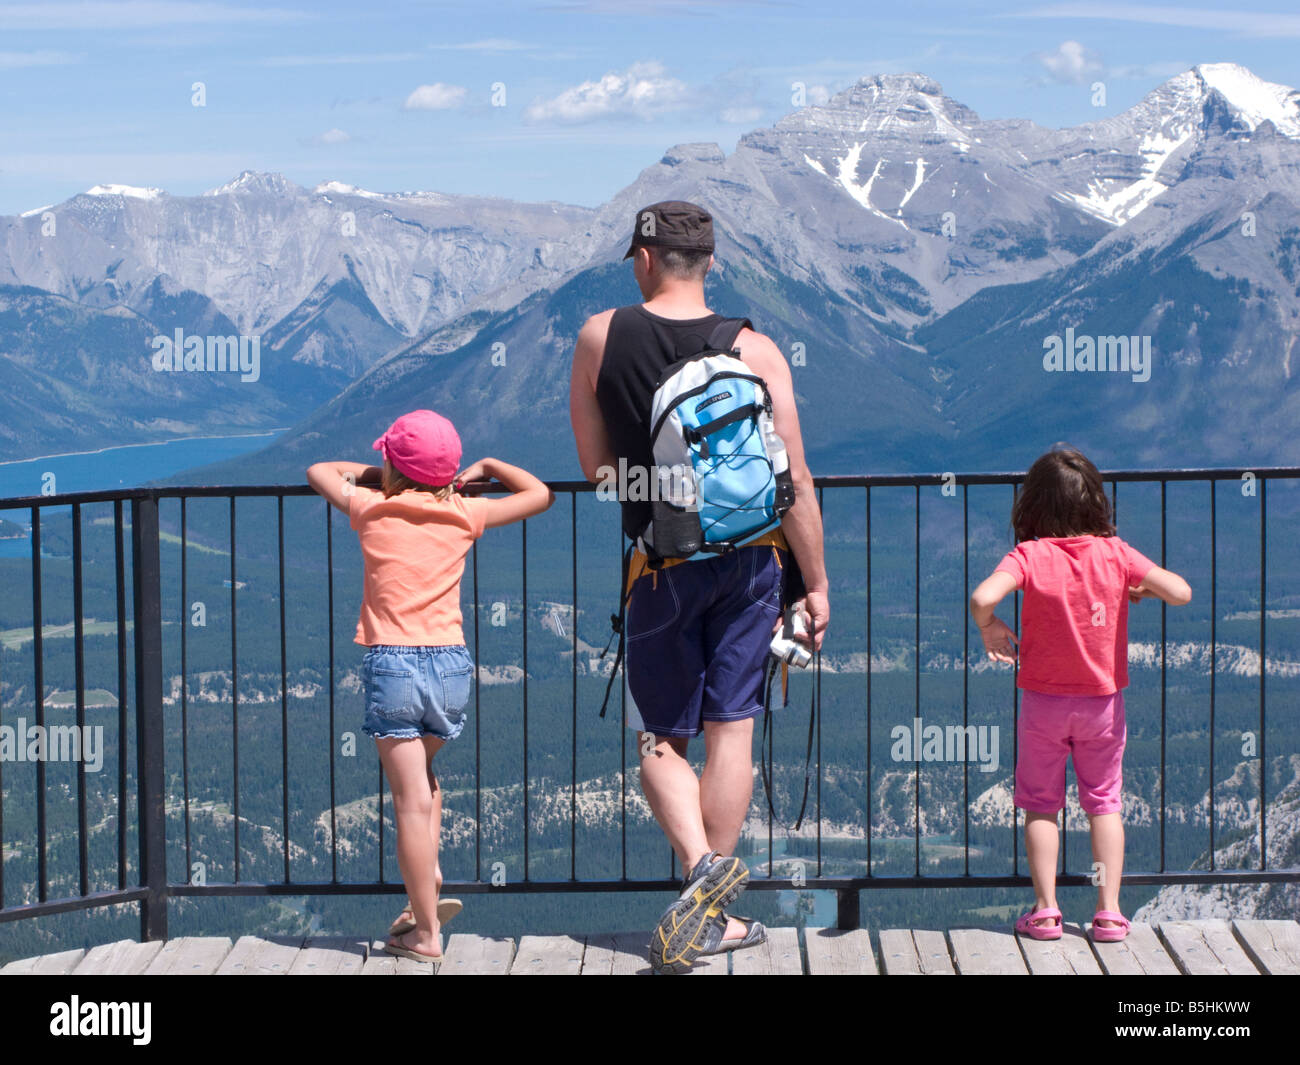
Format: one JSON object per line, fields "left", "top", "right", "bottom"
{"left": 0, "top": 921, "right": 1300, "bottom": 977}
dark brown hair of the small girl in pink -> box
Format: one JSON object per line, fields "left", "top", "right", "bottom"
{"left": 1011, "top": 443, "right": 1115, "bottom": 542}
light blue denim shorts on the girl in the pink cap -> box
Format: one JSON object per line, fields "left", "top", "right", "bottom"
{"left": 361, "top": 644, "right": 475, "bottom": 740}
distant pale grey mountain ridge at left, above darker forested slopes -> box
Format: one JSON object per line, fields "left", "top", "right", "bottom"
{"left": 0, "top": 172, "right": 592, "bottom": 358}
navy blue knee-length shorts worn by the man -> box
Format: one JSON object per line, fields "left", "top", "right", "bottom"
{"left": 624, "top": 544, "right": 785, "bottom": 736}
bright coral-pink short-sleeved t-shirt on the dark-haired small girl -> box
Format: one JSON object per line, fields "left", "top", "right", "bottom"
{"left": 995, "top": 536, "right": 1156, "bottom": 696}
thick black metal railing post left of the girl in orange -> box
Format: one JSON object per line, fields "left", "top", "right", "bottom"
{"left": 131, "top": 497, "right": 168, "bottom": 940}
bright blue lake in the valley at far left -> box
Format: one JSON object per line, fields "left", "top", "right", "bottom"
{"left": 0, "top": 429, "right": 285, "bottom": 558}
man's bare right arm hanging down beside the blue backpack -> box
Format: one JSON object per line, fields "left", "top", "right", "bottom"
{"left": 737, "top": 329, "right": 831, "bottom": 648}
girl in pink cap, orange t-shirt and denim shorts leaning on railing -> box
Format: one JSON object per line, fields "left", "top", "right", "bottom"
{"left": 307, "top": 411, "right": 555, "bottom": 962}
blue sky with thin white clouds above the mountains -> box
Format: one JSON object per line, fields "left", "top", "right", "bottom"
{"left": 0, "top": 0, "right": 1300, "bottom": 213}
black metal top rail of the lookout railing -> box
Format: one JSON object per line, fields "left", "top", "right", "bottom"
{"left": 0, "top": 466, "right": 1300, "bottom": 510}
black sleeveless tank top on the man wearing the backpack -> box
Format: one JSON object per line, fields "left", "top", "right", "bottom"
{"left": 595, "top": 303, "right": 749, "bottom": 538}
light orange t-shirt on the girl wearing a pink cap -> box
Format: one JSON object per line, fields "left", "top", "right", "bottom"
{"left": 348, "top": 485, "right": 488, "bottom": 646}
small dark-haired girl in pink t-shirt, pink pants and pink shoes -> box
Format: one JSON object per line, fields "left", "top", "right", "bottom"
{"left": 971, "top": 445, "right": 1192, "bottom": 943}
